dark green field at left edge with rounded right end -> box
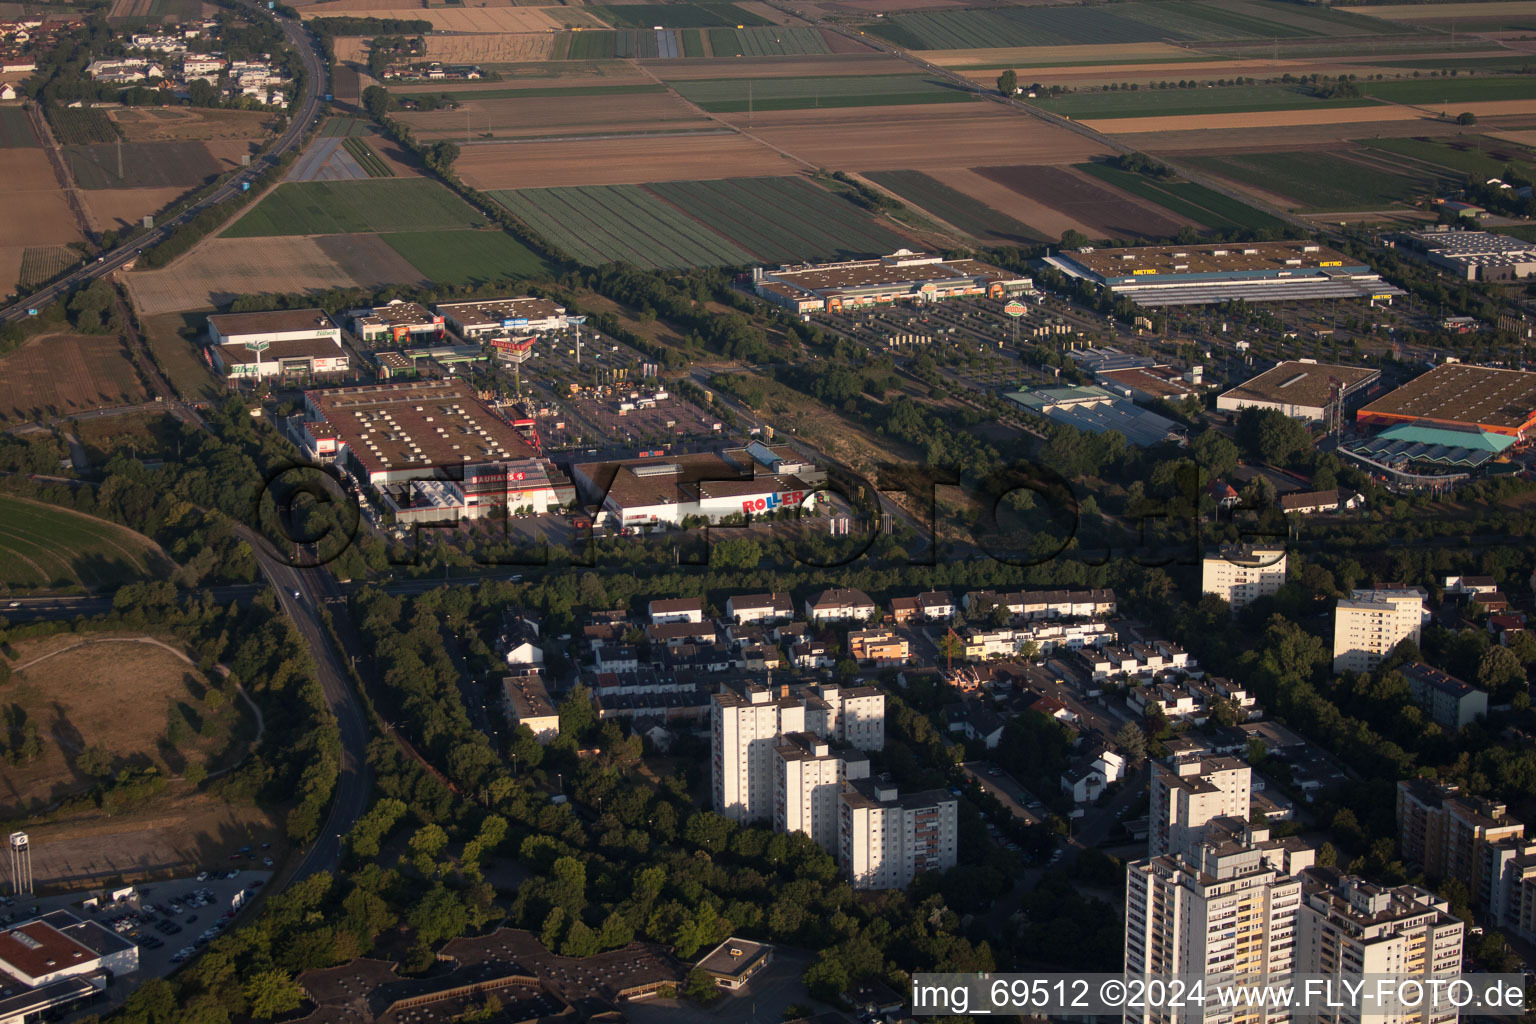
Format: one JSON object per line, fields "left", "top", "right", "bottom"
{"left": 0, "top": 494, "right": 175, "bottom": 590}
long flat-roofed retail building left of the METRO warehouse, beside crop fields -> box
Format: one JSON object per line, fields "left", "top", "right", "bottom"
{"left": 753, "top": 249, "right": 1034, "bottom": 313}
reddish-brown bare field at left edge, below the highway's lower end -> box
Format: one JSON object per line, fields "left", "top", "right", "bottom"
{"left": 0, "top": 335, "right": 149, "bottom": 419}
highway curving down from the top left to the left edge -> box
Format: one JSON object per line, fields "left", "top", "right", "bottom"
{"left": 0, "top": 0, "right": 326, "bottom": 322}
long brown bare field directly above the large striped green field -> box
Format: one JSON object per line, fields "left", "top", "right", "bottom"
{"left": 453, "top": 135, "right": 798, "bottom": 189}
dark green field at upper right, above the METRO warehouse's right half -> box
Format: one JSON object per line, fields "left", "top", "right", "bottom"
{"left": 1187, "top": 152, "right": 1433, "bottom": 212}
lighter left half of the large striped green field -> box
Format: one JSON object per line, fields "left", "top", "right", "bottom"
{"left": 492, "top": 184, "right": 753, "bottom": 269}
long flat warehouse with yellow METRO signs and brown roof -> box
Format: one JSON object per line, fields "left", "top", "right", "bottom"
{"left": 1046, "top": 241, "right": 1402, "bottom": 307}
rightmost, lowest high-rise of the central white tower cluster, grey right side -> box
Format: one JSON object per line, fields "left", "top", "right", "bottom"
{"left": 837, "top": 778, "right": 958, "bottom": 889}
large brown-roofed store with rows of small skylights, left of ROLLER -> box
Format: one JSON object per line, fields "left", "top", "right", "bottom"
{"left": 296, "top": 381, "right": 574, "bottom": 522}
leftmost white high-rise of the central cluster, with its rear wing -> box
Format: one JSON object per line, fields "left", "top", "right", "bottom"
{"left": 710, "top": 685, "right": 885, "bottom": 821}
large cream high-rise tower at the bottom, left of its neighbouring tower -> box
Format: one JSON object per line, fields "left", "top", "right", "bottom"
{"left": 1124, "top": 817, "right": 1313, "bottom": 1024}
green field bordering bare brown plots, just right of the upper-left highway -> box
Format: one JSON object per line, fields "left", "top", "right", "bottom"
{"left": 224, "top": 178, "right": 485, "bottom": 238}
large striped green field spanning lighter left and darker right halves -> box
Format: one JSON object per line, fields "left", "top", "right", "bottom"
{"left": 492, "top": 178, "right": 906, "bottom": 269}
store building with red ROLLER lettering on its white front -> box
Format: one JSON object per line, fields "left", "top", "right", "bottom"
{"left": 571, "top": 441, "right": 826, "bottom": 530}
